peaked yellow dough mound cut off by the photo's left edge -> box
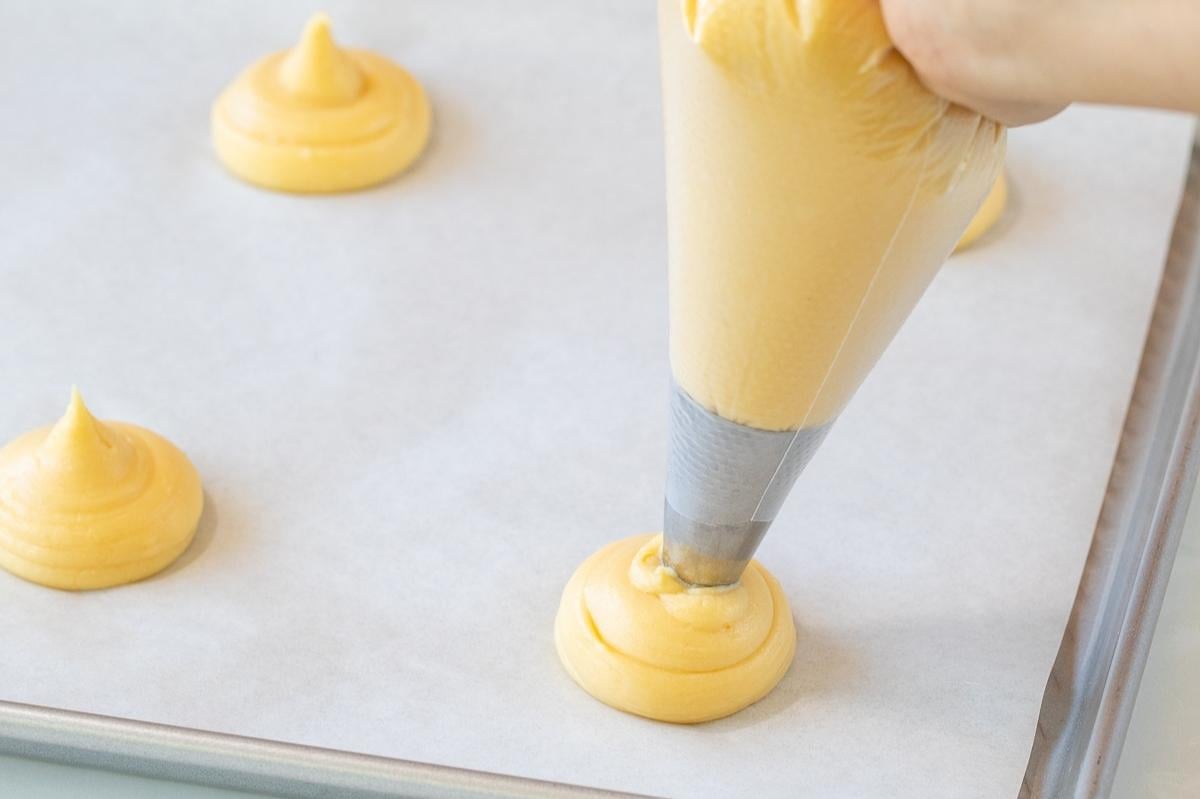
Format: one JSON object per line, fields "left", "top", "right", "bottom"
{"left": 0, "top": 391, "right": 204, "bottom": 590}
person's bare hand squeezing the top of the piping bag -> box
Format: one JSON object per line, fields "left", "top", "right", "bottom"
{"left": 881, "top": 0, "right": 1200, "bottom": 125}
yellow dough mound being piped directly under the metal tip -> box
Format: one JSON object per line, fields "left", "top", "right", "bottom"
{"left": 554, "top": 535, "right": 796, "bottom": 723}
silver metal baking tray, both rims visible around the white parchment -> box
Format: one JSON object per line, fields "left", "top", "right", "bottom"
{"left": 0, "top": 127, "right": 1200, "bottom": 799}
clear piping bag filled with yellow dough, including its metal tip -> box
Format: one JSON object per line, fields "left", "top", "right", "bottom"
{"left": 659, "top": 0, "right": 1004, "bottom": 585}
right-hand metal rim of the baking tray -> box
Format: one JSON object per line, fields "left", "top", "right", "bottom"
{"left": 1020, "top": 131, "right": 1200, "bottom": 799}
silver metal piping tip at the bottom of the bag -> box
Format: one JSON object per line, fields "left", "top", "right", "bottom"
{"left": 662, "top": 384, "right": 833, "bottom": 585}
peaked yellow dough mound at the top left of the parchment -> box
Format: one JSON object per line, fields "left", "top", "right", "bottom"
{"left": 212, "top": 14, "right": 431, "bottom": 192}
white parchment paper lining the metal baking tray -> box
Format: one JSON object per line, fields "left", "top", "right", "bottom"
{"left": 0, "top": 0, "right": 1192, "bottom": 798}
